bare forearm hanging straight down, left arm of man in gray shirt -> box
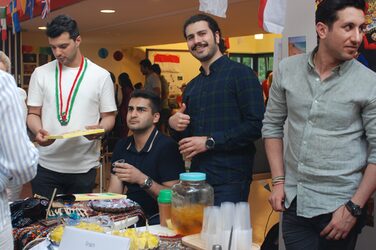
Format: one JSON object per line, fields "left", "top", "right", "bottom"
{"left": 264, "top": 138, "right": 285, "bottom": 177}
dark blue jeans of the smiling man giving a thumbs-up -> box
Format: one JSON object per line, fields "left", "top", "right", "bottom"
{"left": 213, "top": 181, "right": 251, "bottom": 206}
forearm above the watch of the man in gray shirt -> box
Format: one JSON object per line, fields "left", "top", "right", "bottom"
{"left": 351, "top": 163, "right": 376, "bottom": 207}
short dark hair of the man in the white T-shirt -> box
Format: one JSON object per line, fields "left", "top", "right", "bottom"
{"left": 46, "top": 15, "right": 80, "bottom": 40}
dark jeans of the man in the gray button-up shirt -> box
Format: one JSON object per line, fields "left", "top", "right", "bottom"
{"left": 282, "top": 198, "right": 364, "bottom": 250}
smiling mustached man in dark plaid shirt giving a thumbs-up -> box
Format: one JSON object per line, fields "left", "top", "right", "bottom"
{"left": 169, "top": 14, "right": 264, "bottom": 205}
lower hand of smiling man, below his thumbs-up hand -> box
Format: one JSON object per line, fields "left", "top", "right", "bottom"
{"left": 179, "top": 136, "right": 208, "bottom": 160}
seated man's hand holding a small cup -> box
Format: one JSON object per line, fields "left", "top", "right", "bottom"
{"left": 113, "top": 163, "right": 147, "bottom": 185}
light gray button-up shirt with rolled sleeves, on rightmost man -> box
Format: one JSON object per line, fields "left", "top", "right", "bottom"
{"left": 262, "top": 50, "right": 376, "bottom": 218}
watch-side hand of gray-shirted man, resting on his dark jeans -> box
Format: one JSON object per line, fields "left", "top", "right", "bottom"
{"left": 320, "top": 205, "right": 356, "bottom": 240}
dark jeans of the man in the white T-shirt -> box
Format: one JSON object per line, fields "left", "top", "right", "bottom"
{"left": 31, "top": 165, "right": 97, "bottom": 199}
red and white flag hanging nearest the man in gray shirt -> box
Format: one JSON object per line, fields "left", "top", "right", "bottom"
{"left": 258, "top": 0, "right": 287, "bottom": 34}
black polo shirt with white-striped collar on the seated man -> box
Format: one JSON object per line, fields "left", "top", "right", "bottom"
{"left": 111, "top": 129, "right": 185, "bottom": 217}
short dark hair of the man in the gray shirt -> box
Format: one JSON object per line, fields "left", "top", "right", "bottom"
{"left": 315, "top": 0, "right": 366, "bottom": 29}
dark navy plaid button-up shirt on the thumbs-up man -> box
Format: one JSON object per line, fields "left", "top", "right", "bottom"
{"left": 174, "top": 56, "right": 264, "bottom": 185}
